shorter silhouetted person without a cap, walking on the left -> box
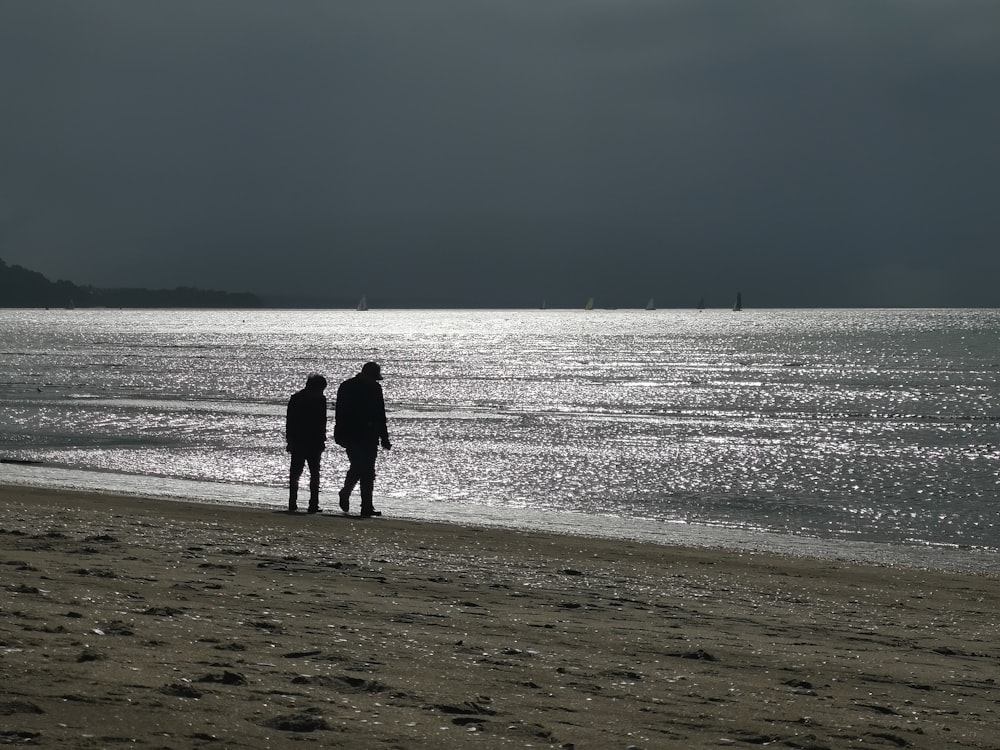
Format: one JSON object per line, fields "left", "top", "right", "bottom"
{"left": 285, "top": 373, "right": 326, "bottom": 513}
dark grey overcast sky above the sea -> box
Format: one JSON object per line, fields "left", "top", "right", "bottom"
{"left": 0, "top": 0, "right": 1000, "bottom": 307}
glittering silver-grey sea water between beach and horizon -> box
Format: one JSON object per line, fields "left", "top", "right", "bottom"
{"left": 0, "top": 309, "right": 1000, "bottom": 570}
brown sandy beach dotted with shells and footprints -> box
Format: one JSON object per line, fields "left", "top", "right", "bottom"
{"left": 0, "top": 487, "right": 1000, "bottom": 750}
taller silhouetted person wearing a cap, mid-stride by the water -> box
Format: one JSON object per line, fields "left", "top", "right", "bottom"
{"left": 333, "top": 362, "right": 392, "bottom": 518}
